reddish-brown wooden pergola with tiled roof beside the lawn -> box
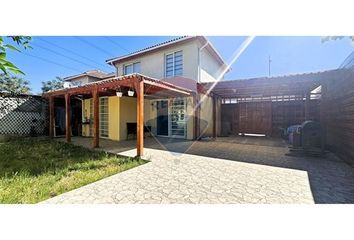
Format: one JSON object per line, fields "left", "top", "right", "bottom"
{"left": 44, "top": 74, "right": 197, "bottom": 157}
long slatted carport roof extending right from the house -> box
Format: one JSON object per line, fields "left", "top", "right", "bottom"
{"left": 205, "top": 69, "right": 346, "bottom": 98}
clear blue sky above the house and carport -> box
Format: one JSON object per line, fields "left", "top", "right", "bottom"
{"left": 8, "top": 36, "right": 354, "bottom": 93}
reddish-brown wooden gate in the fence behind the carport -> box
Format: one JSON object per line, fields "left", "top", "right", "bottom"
{"left": 238, "top": 102, "right": 272, "bottom": 135}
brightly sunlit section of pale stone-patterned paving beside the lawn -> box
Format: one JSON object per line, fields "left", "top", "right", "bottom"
{"left": 42, "top": 149, "right": 313, "bottom": 203}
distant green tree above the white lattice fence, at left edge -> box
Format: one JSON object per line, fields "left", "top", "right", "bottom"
{"left": 0, "top": 73, "right": 31, "bottom": 95}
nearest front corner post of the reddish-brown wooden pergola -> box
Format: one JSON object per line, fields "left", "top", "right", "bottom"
{"left": 135, "top": 79, "right": 144, "bottom": 157}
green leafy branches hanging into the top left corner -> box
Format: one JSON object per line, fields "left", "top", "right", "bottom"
{"left": 0, "top": 36, "right": 32, "bottom": 74}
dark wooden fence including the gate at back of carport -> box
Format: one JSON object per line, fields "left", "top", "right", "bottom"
{"left": 221, "top": 99, "right": 320, "bottom": 136}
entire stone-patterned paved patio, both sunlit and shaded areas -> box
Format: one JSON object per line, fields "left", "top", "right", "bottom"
{"left": 45, "top": 137, "right": 354, "bottom": 203}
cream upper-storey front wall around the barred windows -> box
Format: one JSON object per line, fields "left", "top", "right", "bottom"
{"left": 116, "top": 41, "right": 198, "bottom": 80}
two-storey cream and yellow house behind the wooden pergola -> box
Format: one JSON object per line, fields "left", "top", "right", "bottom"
{"left": 58, "top": 36, "right": 227, "bottom": 140}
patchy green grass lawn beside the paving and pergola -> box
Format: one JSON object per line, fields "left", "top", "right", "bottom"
{"left": 0, "top": 138, "right": 146, "bottom": 203}
